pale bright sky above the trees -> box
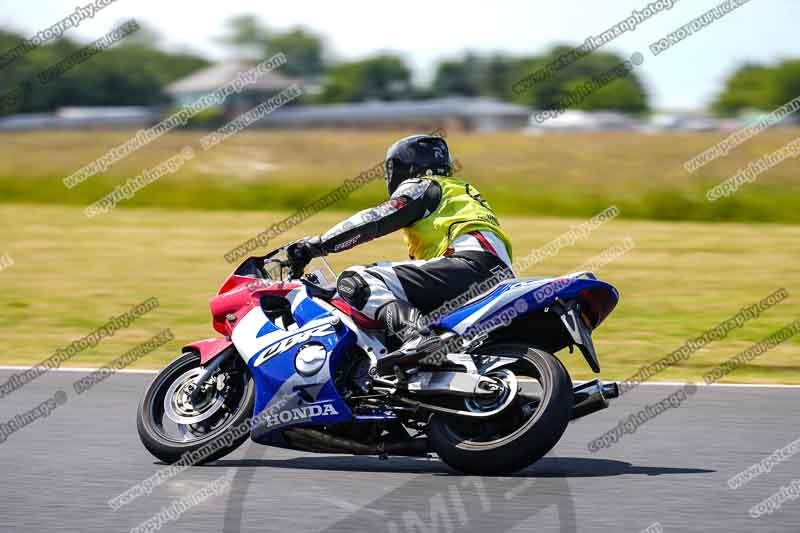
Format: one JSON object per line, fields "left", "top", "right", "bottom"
{"left": 0, "top": 0, "right": 800, "bottom": 109}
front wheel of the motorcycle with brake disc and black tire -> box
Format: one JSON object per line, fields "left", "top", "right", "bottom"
{"left": 136, "top": 347, "right": 255, "bottom": 464}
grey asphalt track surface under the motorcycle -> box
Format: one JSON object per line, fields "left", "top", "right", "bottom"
{"left": 0, "top": 370, "right": 800, "bottom": 533}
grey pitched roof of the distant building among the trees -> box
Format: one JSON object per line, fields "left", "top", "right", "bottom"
{"left": 166, "top": 61, "right": 301, "bottom": 94}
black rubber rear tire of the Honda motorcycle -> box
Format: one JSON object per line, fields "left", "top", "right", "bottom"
{"left": 429, "top": 343, "right": 573, "bottom": 475}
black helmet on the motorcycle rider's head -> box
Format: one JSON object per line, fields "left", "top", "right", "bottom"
{"left": 384, "top": 135, "right": 452, "bottom": 194}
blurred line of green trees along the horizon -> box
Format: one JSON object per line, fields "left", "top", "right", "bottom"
{"left": 0, "top": 15, "right": 800, "bottom": 115}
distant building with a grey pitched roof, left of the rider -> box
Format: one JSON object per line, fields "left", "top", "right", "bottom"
{"left": 166, "top": 61, "right": 306, "bottom": 118}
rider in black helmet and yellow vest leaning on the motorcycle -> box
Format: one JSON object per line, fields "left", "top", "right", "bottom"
{"left": 289, "top": 135, "right": 513, "bottom": 364}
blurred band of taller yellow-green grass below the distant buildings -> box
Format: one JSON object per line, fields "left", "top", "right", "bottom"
{"left": 0, "top": 130, "right": 800, "bottom": 223}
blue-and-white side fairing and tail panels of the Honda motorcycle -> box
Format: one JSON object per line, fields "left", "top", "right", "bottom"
{"left": 241, "top": 274, "right": 619, "bottom": 445}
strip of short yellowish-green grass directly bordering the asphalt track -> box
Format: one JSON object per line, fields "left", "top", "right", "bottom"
{"left": 0, "top": 204, "right": 800, "bottom": 383}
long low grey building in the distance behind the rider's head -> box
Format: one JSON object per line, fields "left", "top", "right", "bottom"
{"left": 258, "top": 97, "right": 530, "bottom": 131}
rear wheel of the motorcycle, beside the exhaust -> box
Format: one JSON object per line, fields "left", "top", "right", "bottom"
{"left": 429, "top": 343, "right": 573, "bottom": 475}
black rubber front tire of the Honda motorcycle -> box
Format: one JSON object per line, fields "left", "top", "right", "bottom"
{"left": 136, "top": 347, "right": 255, "bottom": 464}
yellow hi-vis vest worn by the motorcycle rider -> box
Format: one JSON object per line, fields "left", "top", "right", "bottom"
{"left": 403, "top": 176, "right": 511, "bottom": 260}
